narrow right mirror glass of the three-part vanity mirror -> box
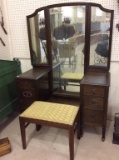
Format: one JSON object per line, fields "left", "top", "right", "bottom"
{"left": 89, "top": 7, "right": 111, "bottom": 67}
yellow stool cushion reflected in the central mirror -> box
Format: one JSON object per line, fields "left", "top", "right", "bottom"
{"left": 61, "top": 72, "right": 84, "bottom": 80}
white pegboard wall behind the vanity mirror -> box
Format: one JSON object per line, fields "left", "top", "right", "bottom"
{"left": 0, "top": 0, "right": 119, "bottom": 115}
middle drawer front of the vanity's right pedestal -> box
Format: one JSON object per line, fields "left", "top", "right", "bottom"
{"left": 83, "top": 96, "right": 104, "bottom": 110}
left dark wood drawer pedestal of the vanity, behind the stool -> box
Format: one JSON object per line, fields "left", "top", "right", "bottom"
{"left": 16, "top": 68, "right": 51, "bottom": 112}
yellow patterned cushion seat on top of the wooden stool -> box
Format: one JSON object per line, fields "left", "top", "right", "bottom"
{"left": 20, "top": 101, "right": 79, "bottom": 125}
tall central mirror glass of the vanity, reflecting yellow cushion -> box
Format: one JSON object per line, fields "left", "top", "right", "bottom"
{"left": 50, "top": 6, "right": 85, "bottom": 92}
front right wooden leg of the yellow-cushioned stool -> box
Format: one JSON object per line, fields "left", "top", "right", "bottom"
{"left": 69, "top": 126, "right": 74, "bottom": 160}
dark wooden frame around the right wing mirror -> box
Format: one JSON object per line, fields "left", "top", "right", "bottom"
{"left": 85, "top": 3, "right": 114, "bottom": 72}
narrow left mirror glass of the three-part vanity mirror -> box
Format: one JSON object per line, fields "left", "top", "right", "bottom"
{"left": 28, "top": 10, "right": 48, "bottom": 65}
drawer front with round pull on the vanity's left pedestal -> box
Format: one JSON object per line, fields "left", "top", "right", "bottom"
{"left": 19, "top": 89, "right": 37, "bottom": 99}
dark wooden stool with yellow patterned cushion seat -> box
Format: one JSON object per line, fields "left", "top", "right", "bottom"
{"left": 19, "top": 101, "right": 80, "bottom": 160}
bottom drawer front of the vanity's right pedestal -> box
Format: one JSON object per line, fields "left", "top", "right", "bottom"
{"left": 83, "top": 109, "right": 103, "bottom": 125}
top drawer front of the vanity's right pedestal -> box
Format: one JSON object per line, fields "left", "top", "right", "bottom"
{"left": 84, "top": 85, "right": 105, "bottom": 97}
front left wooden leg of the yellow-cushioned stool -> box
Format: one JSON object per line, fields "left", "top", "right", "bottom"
{"left": 19, "top": 118, "right": 26, "bottom": 149}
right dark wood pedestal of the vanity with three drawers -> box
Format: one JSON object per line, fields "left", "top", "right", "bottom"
{"left": 80, "top": 72, "right": 110, "bottom": 141}
